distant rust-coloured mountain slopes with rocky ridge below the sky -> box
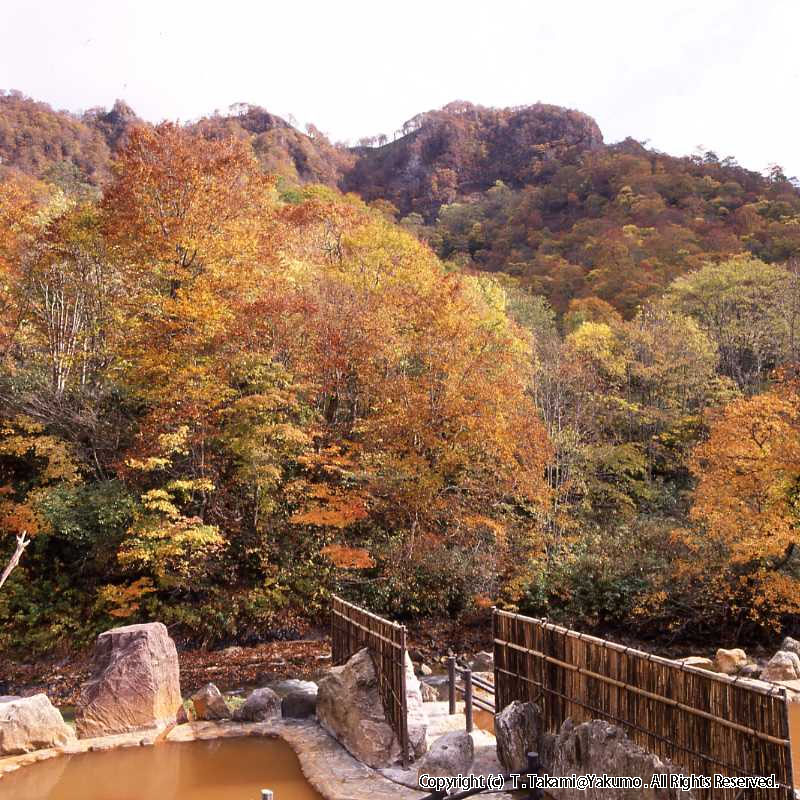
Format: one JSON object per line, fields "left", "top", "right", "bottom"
{"left": 0, "top": 92, "right": 800, "bottom": 316}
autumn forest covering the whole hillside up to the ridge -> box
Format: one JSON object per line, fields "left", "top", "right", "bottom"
{"left": 0, "top": 92, "right": 800, "bottom": 654}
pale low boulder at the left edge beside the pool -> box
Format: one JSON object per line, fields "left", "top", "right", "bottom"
{"left": 0, "top": 694, "right": 75, "bottom": 756}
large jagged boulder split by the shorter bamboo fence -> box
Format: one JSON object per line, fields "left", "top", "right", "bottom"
{"left": 317, "top": 648, "right": 427, "bottom": 768}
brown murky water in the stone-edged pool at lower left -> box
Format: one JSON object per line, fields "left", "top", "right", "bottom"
{"left": 0, "top": 737, "right": 322, "bottom": 800}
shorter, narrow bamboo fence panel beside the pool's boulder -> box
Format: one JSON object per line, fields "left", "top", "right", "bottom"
{"left": 331, "top": 595, "right": 410, "bottom": 766}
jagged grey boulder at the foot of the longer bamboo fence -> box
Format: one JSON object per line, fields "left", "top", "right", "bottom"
{"left": 542, "top": 719, "right": 694, "bottom": 800}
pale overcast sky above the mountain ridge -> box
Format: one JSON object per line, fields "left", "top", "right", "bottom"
{"left": 0, "top": 0, "right": 800, "bottom": 175}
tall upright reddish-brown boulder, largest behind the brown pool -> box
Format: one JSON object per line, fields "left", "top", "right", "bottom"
{"left": 75, "top": 622, "right": 181, "bottom": 738}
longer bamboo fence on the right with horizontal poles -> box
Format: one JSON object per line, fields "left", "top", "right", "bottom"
{"left": 492, "top": 609, "right": 793, "bottom": 800}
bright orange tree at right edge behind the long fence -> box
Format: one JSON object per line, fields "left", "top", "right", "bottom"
{"left": 690, "top": 381, "right": 800, "bottom": 627}
